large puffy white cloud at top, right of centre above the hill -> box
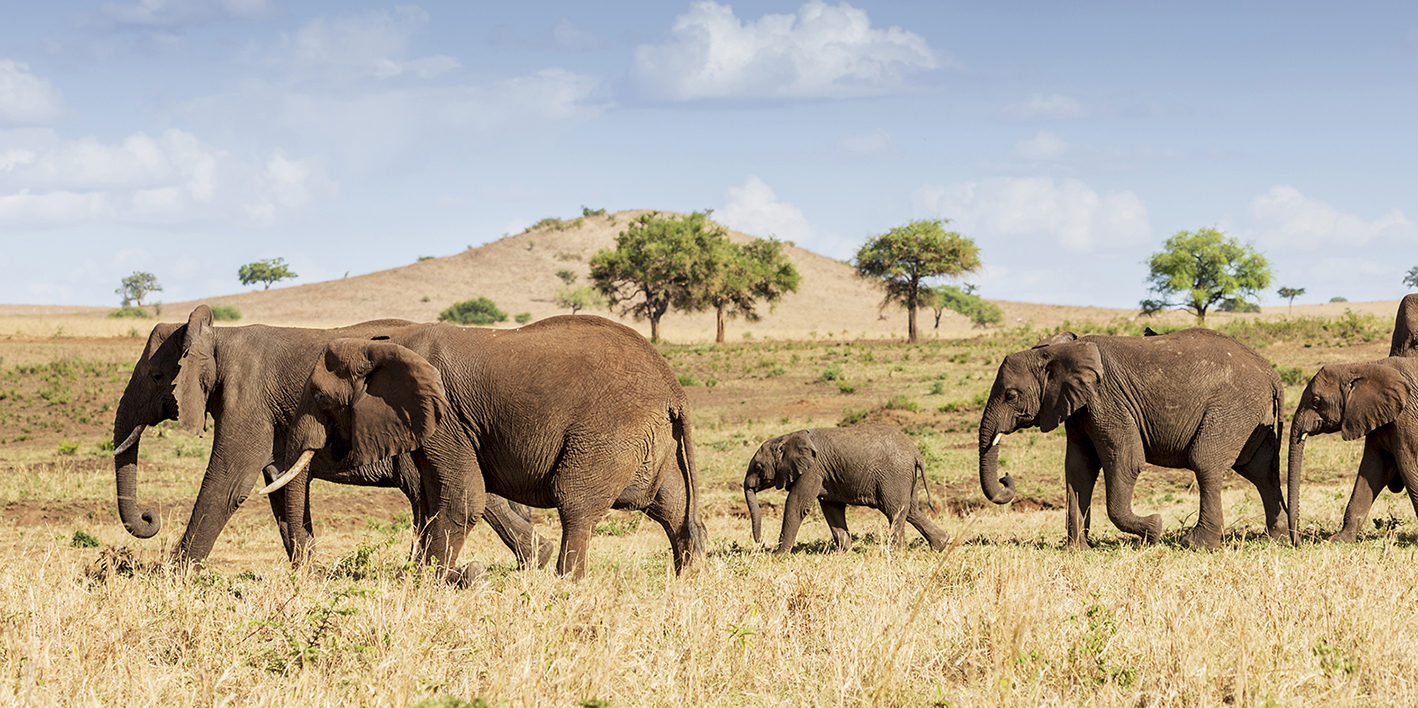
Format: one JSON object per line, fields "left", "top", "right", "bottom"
{"left": 632, "top": 0, "right": 950, "bottom": 101}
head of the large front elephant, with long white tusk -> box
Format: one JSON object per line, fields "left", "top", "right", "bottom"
{"left": 261, "top": 338, "right": 448, "bottom": 494}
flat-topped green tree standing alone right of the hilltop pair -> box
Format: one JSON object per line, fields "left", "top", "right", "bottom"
{"left": 855, "top": 219, "right": 980, "bottom": 343}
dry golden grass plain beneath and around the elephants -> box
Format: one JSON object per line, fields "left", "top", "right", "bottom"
{"left": 0, "top": 312, "right": 1418, "bottom": 707}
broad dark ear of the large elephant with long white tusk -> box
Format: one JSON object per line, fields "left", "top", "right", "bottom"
{"left": 325, "top": 339, "right": 448, "bottom": 465}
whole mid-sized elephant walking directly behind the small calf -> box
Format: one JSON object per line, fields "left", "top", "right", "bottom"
{"left": 980, "top": 329, "right": 1293, "bottom": 548}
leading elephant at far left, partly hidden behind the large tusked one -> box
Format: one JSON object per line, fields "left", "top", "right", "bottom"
{"left": 113, "top": 305, "right": 552, "bottom": 565}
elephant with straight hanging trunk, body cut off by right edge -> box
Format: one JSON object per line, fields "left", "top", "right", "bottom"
{"left": 1288, "top": 360, "right": 1418, "bottom": 542}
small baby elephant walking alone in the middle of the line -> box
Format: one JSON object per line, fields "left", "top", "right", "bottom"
{"left": 743, "top": 423, "right": 950, "bottom": 553}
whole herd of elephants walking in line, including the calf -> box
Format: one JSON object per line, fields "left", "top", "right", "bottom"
{"left": 113, "top": 295, "right": 1418, "bottom": 582}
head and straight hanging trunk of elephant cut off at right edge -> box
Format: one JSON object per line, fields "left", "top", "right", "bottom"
{"left": 1286, "top": 362, "right": 1408, "bottom": 532}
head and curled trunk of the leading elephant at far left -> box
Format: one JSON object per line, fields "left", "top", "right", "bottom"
{"left": 113, "top": 305, "right": 216, "bottom": 538}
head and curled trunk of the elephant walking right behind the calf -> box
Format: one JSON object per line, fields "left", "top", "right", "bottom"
{"left": 980, "top": 341, "right": 1103, "bottom": 504}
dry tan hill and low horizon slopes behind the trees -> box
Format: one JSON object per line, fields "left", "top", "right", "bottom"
{"left": 0, "top": 210, "right": 1397, "bottom": 342}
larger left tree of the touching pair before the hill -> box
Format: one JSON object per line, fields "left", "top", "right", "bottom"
{"left": 590, "top": 211, "right": 727, "bottom": 342}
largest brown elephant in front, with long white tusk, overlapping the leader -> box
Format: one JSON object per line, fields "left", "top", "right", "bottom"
{"left": 259, "top": 315, "right": 705, "bottom": 582}
